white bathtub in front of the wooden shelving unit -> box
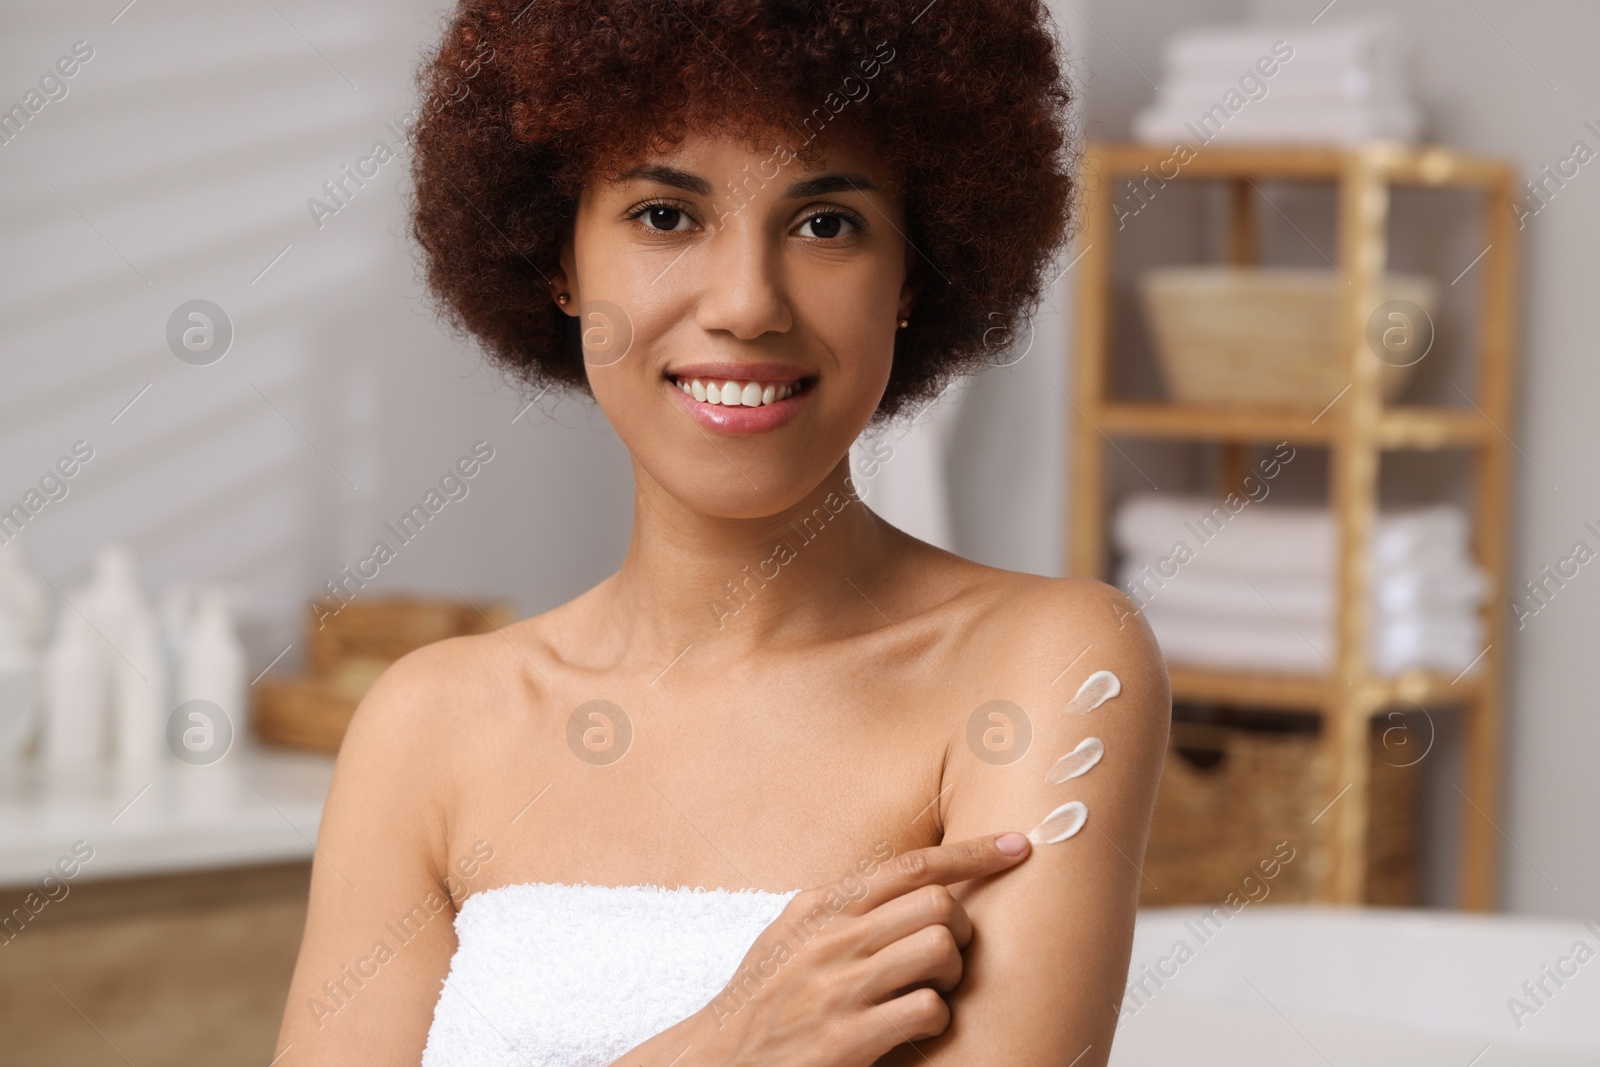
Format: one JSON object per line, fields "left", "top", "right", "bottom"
{"left": 1110, "top": 904, "right": 1600, "bottom": 1067}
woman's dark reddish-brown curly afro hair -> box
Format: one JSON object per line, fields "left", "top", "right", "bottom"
{"left": 411, "top": 0, "right": 1077, "bottom": 418}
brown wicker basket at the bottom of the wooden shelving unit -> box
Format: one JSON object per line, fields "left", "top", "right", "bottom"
{"left": 1139, "top": 721, "right": 1419, "bottom": 907}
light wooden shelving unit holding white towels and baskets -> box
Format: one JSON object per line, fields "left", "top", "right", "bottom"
{"left": 1067, "top": 142, "right": 1518, "bottom": 910}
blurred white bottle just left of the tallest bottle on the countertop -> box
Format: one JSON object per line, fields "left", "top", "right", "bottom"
{"left": 40, "top": 605, "right": 109, "bottom": 773}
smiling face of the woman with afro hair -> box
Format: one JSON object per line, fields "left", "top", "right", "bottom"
{"left": 552, "top": 130, "right": 914, "bottom": 518}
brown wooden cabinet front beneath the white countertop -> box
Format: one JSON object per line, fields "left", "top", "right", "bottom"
{"left": 0, "top": 864, "right": 310, "bottom": 1067}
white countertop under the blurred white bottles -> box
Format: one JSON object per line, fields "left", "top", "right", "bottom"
{"left": 0, "top": 739, "right": 333, "bottom": 886}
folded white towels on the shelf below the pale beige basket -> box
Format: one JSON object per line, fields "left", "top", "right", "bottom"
{"left": 1114, "top": 493, "right": 1490, "bottom": 675}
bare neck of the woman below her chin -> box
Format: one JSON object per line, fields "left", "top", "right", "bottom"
{"left": 606, "top": 456, "right": 912, "bottom": 662}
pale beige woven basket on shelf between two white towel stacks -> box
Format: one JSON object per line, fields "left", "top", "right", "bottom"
{"left": 1139, "top": 267, "right": 1438, "bottom": 410}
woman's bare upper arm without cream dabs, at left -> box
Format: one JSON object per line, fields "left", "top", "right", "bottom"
{"left": 275, "top": 641, "right": 456, "bottom": 1067}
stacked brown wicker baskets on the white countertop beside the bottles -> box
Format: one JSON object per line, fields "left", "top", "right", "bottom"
{"left": 253, "top": 597, "right": 515, "bottom": 752}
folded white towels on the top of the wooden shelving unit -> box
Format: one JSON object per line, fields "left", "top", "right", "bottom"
{"left": 1133, "top": 16, "right": 1421, "bottom": 149}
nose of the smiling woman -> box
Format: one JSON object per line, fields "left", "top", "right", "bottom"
{"left": 694, "top": 214, "right": 794, "bottom": 341}
